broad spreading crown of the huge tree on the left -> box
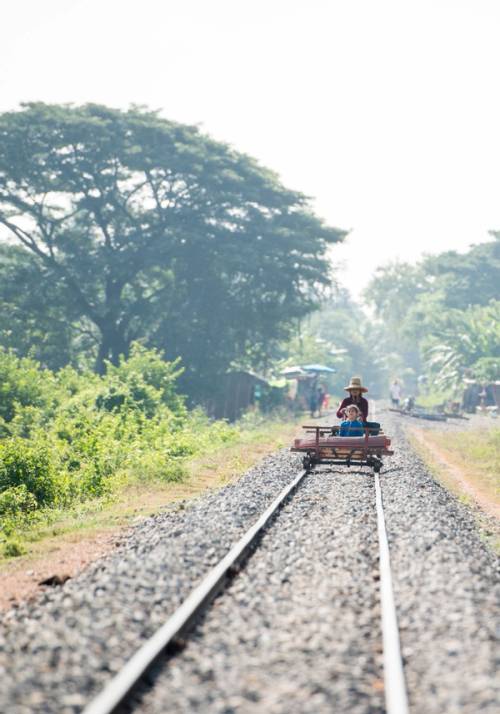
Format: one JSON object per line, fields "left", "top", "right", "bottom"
{"left": 0, "top": 104, "right": 343, "bottom": 386}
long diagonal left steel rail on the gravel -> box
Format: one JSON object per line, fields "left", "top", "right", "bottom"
{"left": 83, "top": 471, "right": 307, "bottom": 714}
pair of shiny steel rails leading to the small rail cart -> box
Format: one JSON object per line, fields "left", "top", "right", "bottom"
{"left": 83, "top": 471, "right": 409, "bottom": 714}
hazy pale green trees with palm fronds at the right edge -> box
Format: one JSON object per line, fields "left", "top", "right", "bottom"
{"left": 365, "top": 231, "right": 500, "bottom": 389}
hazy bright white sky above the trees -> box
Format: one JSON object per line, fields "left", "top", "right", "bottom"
{"left": 0, "top": 0, "right": 500, "bottom": 294}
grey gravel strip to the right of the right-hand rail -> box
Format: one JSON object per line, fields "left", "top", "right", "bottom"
{"left": 376, "top": 412, "right": 500, "bottom": 714}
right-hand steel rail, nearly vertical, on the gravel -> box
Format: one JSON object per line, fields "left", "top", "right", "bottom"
{"left": 375, "top": 473, "right": 409, "bottom": 714}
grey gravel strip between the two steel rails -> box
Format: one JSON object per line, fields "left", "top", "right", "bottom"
{"left": 125, "top": 471, "right": 384, "bottom": 714}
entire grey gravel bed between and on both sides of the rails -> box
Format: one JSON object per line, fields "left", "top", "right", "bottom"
{"left": 0, "top": 413, "right": 499, "bottom": 714}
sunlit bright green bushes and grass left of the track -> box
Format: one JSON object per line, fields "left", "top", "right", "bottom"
{"left": 0, "top": 345, "right": 300, "bottom": 557}
